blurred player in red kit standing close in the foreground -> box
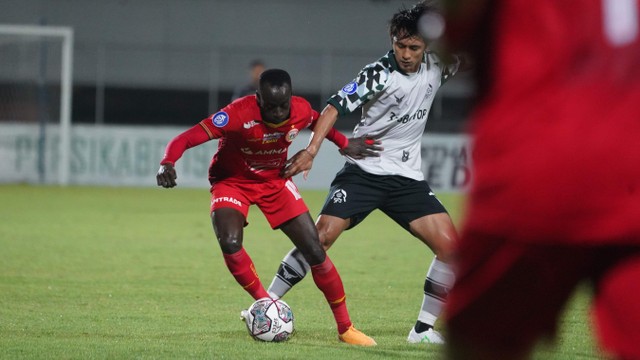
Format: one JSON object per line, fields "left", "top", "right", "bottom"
{"left": 446, "top": 0, "right": 640, "bottom": 359}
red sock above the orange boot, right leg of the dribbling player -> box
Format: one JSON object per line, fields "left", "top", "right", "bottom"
{"left": 311, "top": 256, "right": 351, "bottom": 334}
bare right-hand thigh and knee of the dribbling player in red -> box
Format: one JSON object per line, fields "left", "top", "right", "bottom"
{"left": 280, "top": 212, "right": 326, "bottom": 266}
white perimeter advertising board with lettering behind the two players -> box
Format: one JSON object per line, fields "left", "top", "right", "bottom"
{"left": 0, "top": 123, "right": 470, "bottom": 192}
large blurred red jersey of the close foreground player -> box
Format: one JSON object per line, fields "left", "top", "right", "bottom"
{"left": 454, "top": 0, "right": 640, "bottom": 244}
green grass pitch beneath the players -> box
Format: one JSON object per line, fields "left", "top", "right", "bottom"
{"left": 0, "top": 185, "right": 602, "bottom": 360}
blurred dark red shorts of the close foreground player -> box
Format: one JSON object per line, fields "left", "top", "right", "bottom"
{"left": 446, "top": 233, "right": 640, "bottom": 359}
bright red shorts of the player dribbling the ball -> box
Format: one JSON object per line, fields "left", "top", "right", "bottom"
{"left": 210, "top": 180, "right": 309, "bottom": 229}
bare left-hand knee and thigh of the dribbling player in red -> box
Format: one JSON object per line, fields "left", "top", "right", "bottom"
{"left": 211, "top": 208, "right": 245, "bottom": 254}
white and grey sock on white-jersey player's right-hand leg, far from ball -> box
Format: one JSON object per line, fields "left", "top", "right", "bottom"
{"left": 418, "top": 257, "right": 455, "bottom": 326}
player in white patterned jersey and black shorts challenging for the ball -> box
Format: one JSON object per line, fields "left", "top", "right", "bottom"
{"left": 268, "top": 2, "right": 472, "bottom": 344}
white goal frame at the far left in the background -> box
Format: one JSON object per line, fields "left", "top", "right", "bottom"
{"left": 0, "top": 24, "right": 74, "bottom": 185}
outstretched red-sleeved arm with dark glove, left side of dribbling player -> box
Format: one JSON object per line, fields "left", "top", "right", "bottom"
{"left": 156, "top": 118, "right": 213, "bottom": 188}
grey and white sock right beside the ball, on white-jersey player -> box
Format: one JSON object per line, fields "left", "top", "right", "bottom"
{"left": 267, "top": 248, "right": 311, "bottom": 299}
